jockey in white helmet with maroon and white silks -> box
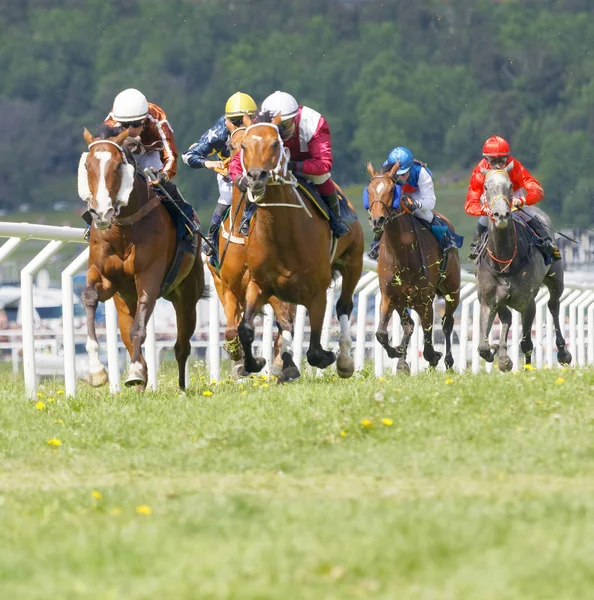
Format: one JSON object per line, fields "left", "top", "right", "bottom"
{"left": 229, "top": 91, "right": 349, "bottom": 237}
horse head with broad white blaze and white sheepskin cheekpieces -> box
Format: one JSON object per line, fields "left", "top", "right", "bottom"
{"left": 78, "top": 127, "right": 135, "bottom": 230}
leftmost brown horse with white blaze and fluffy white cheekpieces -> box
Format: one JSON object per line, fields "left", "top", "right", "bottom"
{"left": 78, "top": 126, "right": 204, "bottom": 390}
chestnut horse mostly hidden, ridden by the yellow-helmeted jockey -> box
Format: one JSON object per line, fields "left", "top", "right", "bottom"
{"left": 208, "top": 122, "right": 295, "bottom": 375}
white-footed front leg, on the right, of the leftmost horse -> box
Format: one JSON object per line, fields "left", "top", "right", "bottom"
{"left": 124, "top": 273, "right": 161, "bottom": 387}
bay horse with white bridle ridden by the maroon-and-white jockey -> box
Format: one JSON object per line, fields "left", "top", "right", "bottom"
{"left": 234, "top": 113, "right": 363, "bottom": 381}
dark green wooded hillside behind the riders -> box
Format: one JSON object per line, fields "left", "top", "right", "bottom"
{"left": 0, "top": 0, "right": 594, "bottom": 224}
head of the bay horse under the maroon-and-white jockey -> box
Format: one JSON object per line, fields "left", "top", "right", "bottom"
{"left": 241, "top": 113, "right": 289, "bottom": 196}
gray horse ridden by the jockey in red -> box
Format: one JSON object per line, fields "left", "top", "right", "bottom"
{"left": 477, "top": 162, "right": 571, "bottom": 371}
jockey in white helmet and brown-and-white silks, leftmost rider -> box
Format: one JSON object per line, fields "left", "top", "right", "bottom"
{"left": 82, "top": 88, "right": 199, "bottom": 239}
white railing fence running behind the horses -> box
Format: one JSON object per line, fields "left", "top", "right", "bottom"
{"left": 0, "top": 222, "right": 594, "bottom": 398}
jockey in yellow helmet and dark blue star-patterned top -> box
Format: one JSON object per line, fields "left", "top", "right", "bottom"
{"left": 182, "top": 92, "right": 257, "bottom": 256}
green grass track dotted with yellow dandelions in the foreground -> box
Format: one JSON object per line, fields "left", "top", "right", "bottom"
{"left": 0, "top": 369, "right": 594, "bottom": 599}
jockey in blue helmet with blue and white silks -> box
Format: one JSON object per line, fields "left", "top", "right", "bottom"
{"left": 365, "top": 146, "right": 457, "bottom": 260}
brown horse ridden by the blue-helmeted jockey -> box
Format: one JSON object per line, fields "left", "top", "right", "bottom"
{"left": 367, "top": 163, "right": 460, "bottom": 372}
